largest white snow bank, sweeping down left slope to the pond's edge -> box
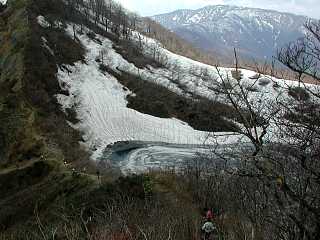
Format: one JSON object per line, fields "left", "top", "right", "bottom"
{"left": 57, "top": 26, "right": 241, "bottom": 158}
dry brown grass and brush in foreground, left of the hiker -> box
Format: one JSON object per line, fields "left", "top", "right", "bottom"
{"left": 0, "top": 172, "right": 200, "bottom": 240}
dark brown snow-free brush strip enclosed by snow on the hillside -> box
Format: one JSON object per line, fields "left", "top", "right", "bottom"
{"left": 103, "top": 66, "right": 240, "bottom": 131}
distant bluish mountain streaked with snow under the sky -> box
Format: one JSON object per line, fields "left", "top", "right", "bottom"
{"left": 152, "top": 5, "right": 308, "bottom": 59}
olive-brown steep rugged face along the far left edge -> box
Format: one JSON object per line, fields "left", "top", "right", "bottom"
{"left": 0, "top": 1, "right": 51, "bottom": 166}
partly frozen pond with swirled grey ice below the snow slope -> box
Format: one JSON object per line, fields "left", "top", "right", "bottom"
{"left": 101, "top": 141, "right": 249, "bottom": 174}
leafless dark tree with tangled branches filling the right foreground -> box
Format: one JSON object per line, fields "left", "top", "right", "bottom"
{"left": 192, "top": 22, "right": 320, "bottom": 239}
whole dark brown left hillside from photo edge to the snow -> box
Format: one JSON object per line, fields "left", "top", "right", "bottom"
{"left": 0, "top": 0, "right": 89, "bottom": 169}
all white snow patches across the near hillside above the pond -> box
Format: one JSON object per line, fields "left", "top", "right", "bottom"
{"left": 43, "top": 16, "right": 316, "bottom": 159}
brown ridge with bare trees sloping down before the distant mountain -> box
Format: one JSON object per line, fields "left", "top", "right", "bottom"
{"left": 65, "top": 0, "right": 217, "bottom": 65}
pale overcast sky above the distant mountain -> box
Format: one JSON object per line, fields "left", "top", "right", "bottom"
{"left": 118, "top": 0, "right": 320, "bottom": 19}
